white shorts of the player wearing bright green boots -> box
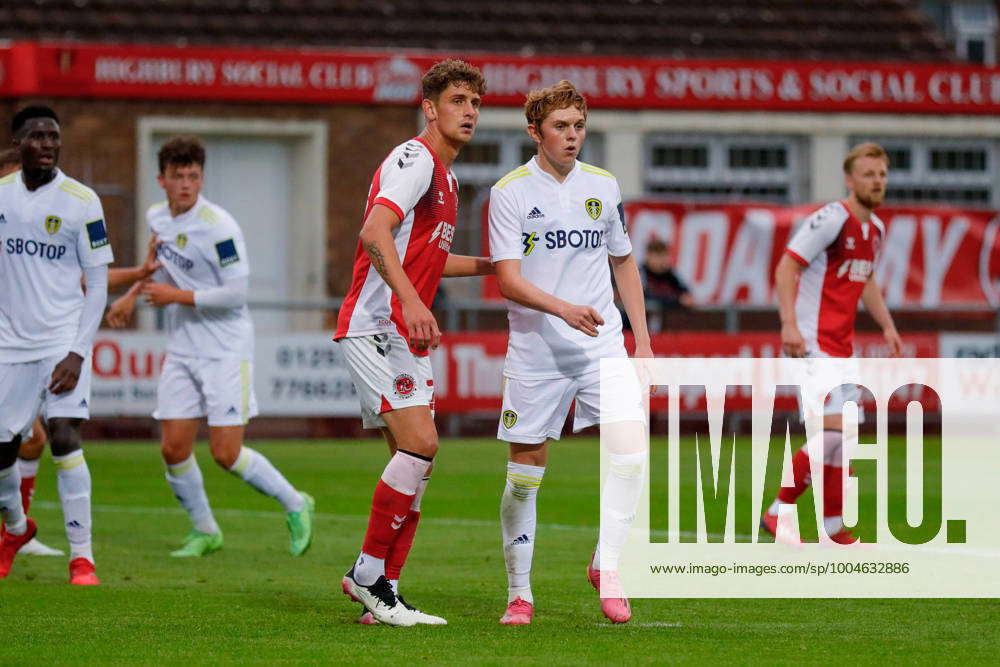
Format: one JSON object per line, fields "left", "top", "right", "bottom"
{"left": 153, "top": 354, "right": 257, "bottom": 426}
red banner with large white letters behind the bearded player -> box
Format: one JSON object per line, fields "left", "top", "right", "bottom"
{"left": 483, "top": 201, "right": 1000, "bottom": 308}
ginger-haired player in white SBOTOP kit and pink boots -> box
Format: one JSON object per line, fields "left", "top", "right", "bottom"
{"left": 489, "top": 81, "right": 653, "bottom": 625}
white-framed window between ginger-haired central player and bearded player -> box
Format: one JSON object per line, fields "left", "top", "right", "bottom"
{"left": 644, "top": 133, "right": 808, "bottom": 203}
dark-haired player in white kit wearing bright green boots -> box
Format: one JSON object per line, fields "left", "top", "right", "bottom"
{"left": 113, "top": 137, "right": 315, "bottom": 557}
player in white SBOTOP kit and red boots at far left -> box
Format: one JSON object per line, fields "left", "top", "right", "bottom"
{"left": 0, "top": 106, "right": 113, "bottom": 586}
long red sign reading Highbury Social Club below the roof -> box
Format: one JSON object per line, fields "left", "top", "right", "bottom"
{"left": 7, "top": 42, "right": 1000, "bottom": 114}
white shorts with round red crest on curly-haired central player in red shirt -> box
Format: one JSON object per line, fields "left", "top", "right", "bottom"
{"left": 339, "top": 333, "right": 434, "bottom": 428}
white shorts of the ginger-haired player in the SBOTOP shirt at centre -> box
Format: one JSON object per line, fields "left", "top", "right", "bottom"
{"left": 497, "top": 365, "right": 646, "bottom": 445}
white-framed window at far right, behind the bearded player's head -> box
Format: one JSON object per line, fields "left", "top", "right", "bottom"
{"left": 852, "top": 137, "right": 1000, "bottom": 207}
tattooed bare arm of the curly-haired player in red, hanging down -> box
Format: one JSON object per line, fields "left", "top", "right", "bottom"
{"left": 361, "top": 204, "right": 441, "bottom": 350}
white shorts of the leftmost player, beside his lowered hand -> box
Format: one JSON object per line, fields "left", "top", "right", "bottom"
{"left": 0, "top": 354, "right": 93, "bottom": 442}
